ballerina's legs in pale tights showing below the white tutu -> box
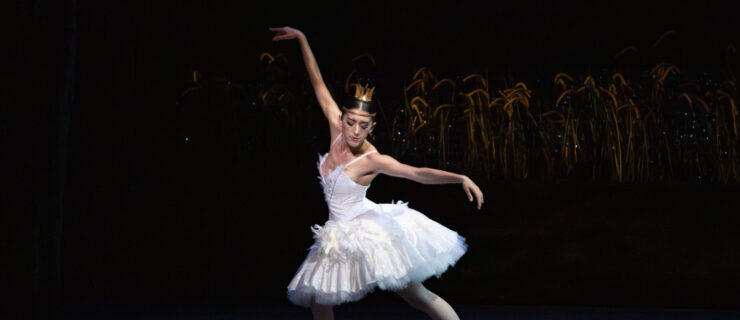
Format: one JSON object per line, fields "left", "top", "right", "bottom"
{"left": 311, "top": 282, "right": 460, "bottom": 320}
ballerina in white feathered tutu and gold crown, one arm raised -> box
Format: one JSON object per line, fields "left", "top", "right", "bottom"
{"left": 270, "top": 27, "right": 483, "bottom": 319}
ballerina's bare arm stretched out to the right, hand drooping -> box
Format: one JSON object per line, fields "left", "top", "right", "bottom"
{"left": 373, "top": 154, "right": 483, "bottom": 209}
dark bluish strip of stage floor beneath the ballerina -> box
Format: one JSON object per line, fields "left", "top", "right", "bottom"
{"left": 50, "top": 299, "right": 740, "bottom": 320}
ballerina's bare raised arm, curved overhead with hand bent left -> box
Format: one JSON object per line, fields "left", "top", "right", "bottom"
{"left": 270, "top": 27, "right": 342, "bottom": 131}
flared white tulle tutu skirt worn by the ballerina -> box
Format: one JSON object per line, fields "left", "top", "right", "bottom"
{"left": 288, "top": 202, "right": 467, "bottom": 307}
